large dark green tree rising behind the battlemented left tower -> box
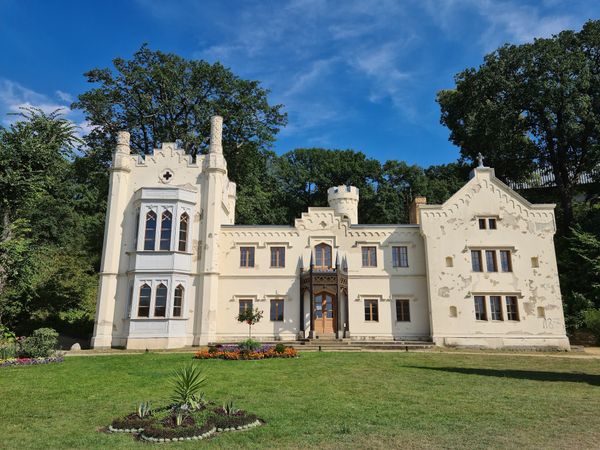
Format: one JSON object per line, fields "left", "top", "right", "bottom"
{"left": 72, "top": 45, "right": 287, "bottom": 223}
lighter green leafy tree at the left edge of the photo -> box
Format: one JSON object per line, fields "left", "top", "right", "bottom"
{"left": 0, "top": 108, "right": 80, "bottom": 322}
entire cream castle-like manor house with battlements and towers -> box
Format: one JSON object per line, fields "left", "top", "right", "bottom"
{"left": 92, "top": 117, "right": 569, "bottom": 349}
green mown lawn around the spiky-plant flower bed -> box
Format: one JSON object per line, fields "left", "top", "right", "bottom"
{"left": 0, "top": 352, "right": 600, "bottom": 449}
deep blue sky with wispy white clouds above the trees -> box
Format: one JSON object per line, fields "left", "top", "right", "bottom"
{"left": 0, "top": 0, "right": 600, "bottom": 166}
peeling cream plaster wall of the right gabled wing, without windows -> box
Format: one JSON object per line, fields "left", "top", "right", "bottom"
{"left": 420, "top": 168, "right": 569, "bottom": 349}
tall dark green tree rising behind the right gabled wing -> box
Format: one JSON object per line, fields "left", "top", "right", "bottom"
{"left": 437, "top": 21, "right": 600, "bottom": 231}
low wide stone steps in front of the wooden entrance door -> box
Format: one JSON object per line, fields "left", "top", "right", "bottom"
{"left": 285, "top": 338, "right": 435, "bottom": 352}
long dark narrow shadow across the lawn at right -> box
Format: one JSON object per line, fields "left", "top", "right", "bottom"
{"left": 409, "top": 366, "right": 600, "bottom": 386}
